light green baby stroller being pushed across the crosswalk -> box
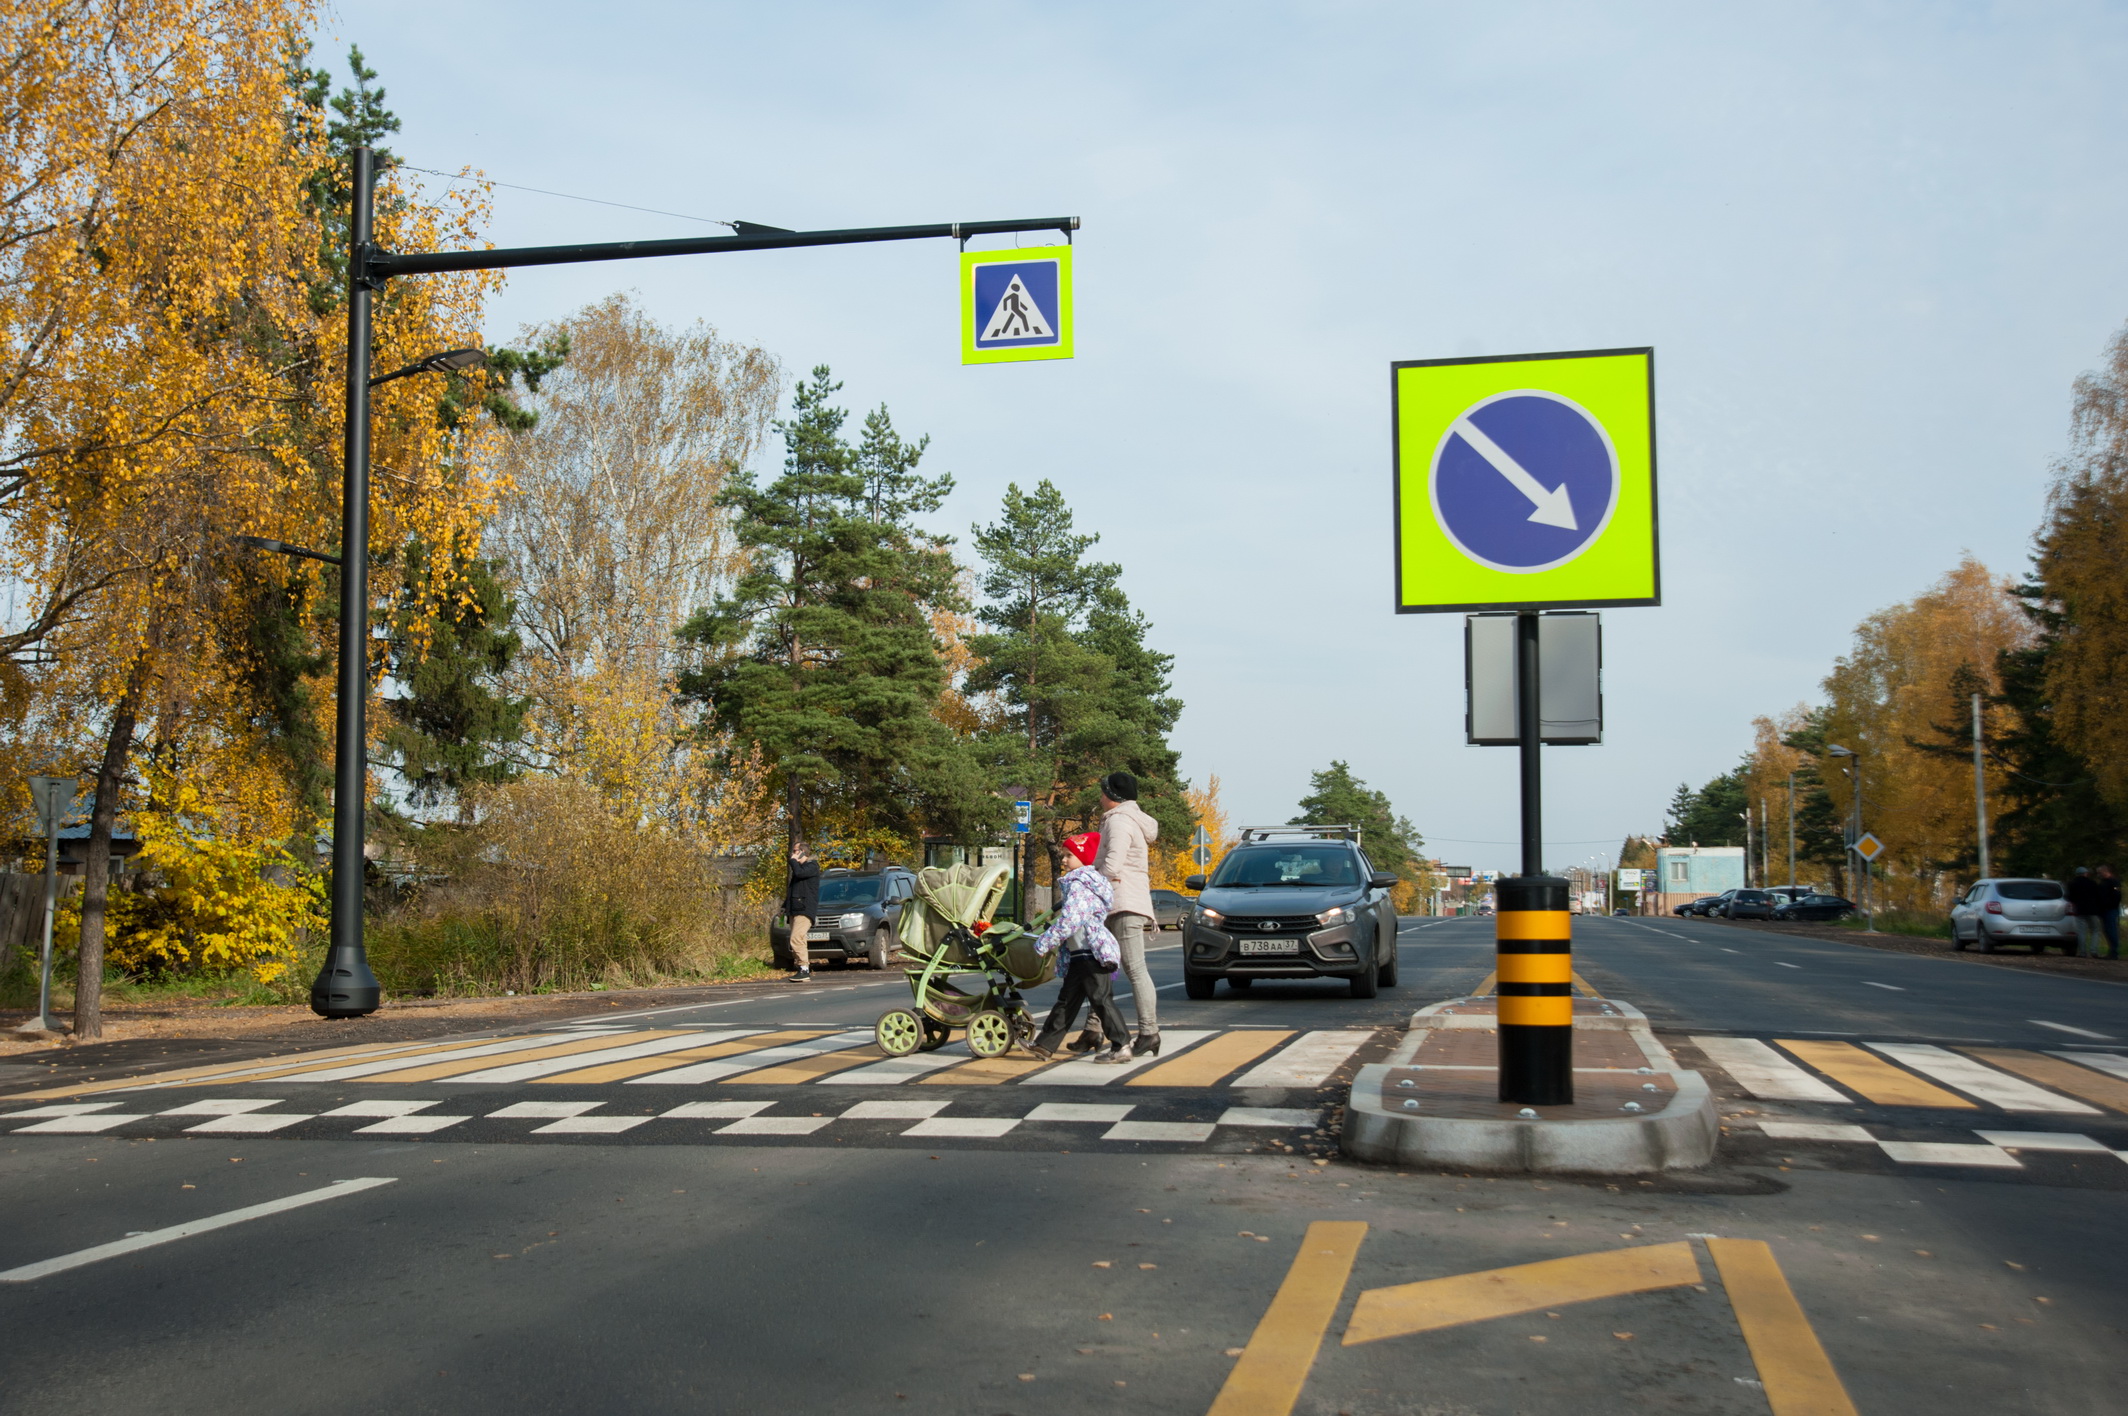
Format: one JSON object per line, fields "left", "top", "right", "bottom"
{"left": 872, "top": 865, "right": 1055, "bottom": 1056}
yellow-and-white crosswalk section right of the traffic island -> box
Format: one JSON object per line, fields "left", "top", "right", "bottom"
{"left": 1692, "top": 1037, "right": 2128, "bottom": 1186}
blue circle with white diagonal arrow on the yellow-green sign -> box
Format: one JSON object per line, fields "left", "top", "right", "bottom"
{"left": 1428, "top": 390, "right": 1619, "bottom": 575}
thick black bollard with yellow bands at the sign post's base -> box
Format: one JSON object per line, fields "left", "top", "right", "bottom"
{"left": 1494, "top": 875, "right": 1575, "bottom": 1107}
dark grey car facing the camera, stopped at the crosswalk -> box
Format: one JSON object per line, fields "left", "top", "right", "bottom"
{"left": 1183, "top": 826, "right": 1396, "bottom": 999}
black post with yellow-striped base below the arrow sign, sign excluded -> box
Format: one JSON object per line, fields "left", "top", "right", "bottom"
{"left": 1494, "top": 611, "right": 1575, "bottom": 1107}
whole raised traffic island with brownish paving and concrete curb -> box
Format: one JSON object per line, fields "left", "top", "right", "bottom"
{"left": 1341, "top": 997, "right": 1722, "bottom": 1175}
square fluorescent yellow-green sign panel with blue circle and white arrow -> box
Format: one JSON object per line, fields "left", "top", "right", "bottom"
{"left": 1390, "top": 349, "right": 1662, "bottom": 613}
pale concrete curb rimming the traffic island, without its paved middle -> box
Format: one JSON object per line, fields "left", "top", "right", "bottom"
{"left": 1341, "top": 999, "right": 1722, "bottom": 1175}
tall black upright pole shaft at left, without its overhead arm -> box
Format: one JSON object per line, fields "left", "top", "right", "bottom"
{"left": 311, "top": 147, "right": 381, "bottom": 1018}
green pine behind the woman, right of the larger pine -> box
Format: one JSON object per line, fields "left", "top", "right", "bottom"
{"left": 968, "top": 481, "right": 1190, "bottom": 869}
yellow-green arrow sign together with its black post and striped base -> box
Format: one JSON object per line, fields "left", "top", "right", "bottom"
{"left": 1390, "top": 349, "right": 1662, "bottom": 1105}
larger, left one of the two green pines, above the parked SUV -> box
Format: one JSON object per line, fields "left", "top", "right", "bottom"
{"left": 681, "top": 366, "right": 1002, "bottom": 839}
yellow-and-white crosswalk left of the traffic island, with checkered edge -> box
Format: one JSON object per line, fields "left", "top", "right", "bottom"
{"left": 0, "top": 1026, "right": 1394, "bottom": 1154}
